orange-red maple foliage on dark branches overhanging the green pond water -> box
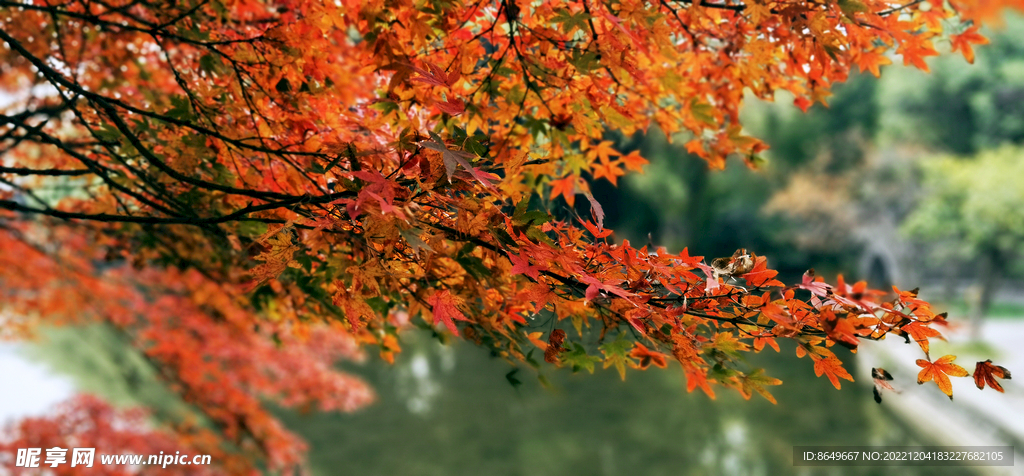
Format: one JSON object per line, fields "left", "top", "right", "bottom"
{"left": 0, "top": 0, "right": 1021, "bottom": 472}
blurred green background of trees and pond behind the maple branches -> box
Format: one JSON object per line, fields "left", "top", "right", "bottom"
{"left": 12, "top": 12, "right": 1024, "bottom": 476}
